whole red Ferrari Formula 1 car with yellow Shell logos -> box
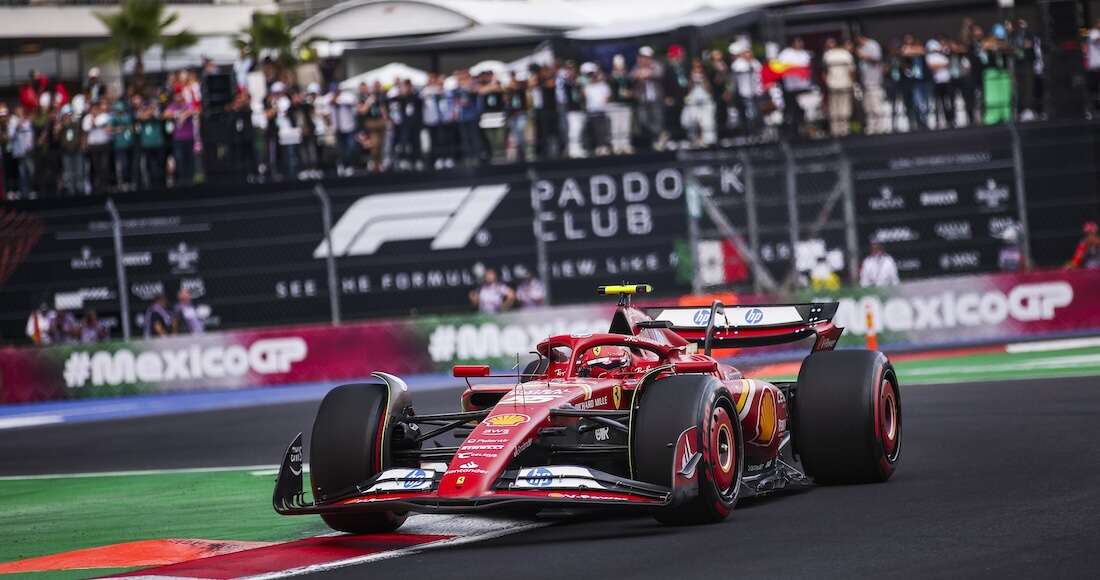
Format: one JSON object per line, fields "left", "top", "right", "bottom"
{"left": 274, "top": 285, "right": 901, "bottom": 533}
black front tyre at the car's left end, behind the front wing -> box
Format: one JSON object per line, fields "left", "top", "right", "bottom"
{"left": 309, "top": 383, "right": 408, "bottom": 534}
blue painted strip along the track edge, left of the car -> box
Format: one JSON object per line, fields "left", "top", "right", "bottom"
{"left": 0, "top": 374, "right": 463, "bottom": 424}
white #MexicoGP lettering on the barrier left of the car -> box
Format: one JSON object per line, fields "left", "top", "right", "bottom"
{"left": 62, "top": 337, "right": 308, "bottom": 389}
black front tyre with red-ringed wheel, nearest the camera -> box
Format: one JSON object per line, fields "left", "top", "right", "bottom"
{"left": 630, "top": 374, "right": 745, "bottom": 525}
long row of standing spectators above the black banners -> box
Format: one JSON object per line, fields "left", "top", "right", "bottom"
{"left": 0, "top": 15, "right": 1100, "bottom": 197}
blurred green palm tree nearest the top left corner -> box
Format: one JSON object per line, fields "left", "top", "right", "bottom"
{"left": 88, "top": 0, "right": 198, "bottom": 85}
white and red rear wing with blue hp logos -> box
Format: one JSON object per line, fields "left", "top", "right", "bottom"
{"left": 639, "top": 302, "right": 844, "bottom": 354}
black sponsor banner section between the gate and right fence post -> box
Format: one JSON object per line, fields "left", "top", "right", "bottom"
{"left": 848, "top": 128, "right": 1019, "bottom": 278}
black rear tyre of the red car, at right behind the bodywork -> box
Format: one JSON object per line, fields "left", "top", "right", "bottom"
{"left": 793, "top": 350, "right": 902, "bottom": 484}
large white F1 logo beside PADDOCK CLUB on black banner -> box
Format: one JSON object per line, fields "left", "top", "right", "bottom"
{"left": 314, "top": 185, "right": 508, "bottom": 258}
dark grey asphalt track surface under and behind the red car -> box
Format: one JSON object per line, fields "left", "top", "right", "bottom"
{"left": 0, "top": 377, "right": 1100, "bottom": 579}
